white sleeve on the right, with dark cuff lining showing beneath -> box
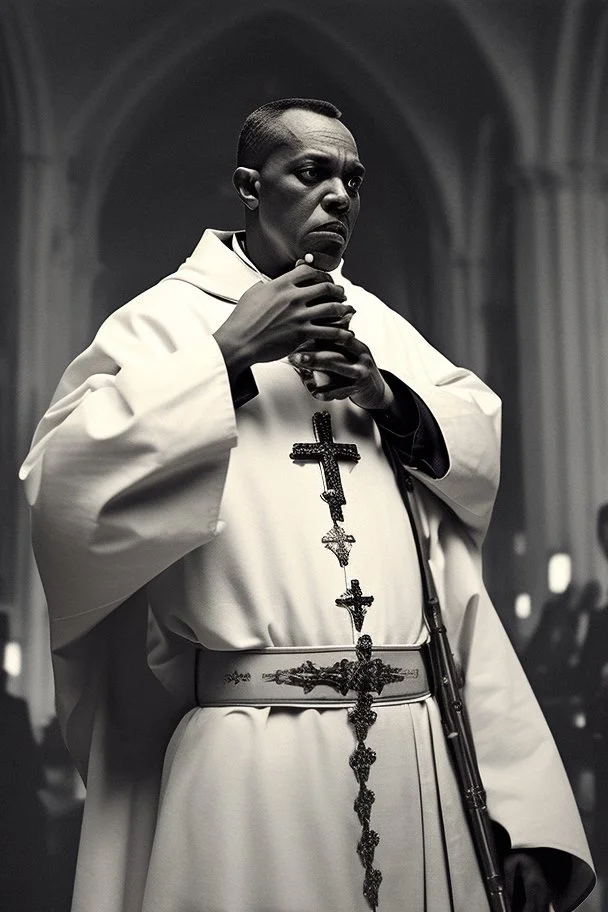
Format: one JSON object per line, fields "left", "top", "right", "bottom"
{"left": 346, "top": 283, "right": 501, "bottom": 544}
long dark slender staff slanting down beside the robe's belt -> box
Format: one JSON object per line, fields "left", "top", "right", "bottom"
{"left": 402, "top": 470, "right": 509, "bottom": 912}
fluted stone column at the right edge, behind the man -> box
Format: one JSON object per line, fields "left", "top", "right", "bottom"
{"left": 515, "top": 163, "right": 608, "bottom": 606}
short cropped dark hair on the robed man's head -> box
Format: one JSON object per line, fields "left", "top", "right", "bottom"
{"left": 236, "top": 98, "right": 342, "bottom": 169}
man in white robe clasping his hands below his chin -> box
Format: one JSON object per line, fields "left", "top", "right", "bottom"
{"left": 23, "top": 99, "right": 593, "bottom": 912}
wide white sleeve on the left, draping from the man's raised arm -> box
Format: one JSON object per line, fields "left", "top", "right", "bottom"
{"left": 21, "top": 283, "right": 236, "bottom": 649}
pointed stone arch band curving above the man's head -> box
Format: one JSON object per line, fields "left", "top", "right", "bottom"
{"left": 67, "top": 3, "right": 457, "bottom": 253}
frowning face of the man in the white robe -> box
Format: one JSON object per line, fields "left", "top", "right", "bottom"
{"left": 255, "top": 109, "right": 365, "bottom": 277}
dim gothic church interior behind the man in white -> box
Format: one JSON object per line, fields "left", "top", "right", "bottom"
{"left": 0, "top": 0, "right": 608, "bottom": 912}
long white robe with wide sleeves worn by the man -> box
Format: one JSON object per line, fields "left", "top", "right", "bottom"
{"left": 22, "top": 231, "right": 593, "bottom": 912}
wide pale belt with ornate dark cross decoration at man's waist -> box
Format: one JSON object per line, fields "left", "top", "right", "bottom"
{"left": 195, "top": 644, "right": 431, "bottom": 707}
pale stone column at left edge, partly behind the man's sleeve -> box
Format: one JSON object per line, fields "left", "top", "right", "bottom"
{"left": 12, "top": 155, "right": 101, "bottom": 726}
